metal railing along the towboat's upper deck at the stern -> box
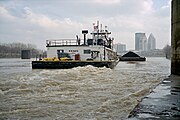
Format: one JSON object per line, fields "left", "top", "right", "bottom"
{"left": 46, "top": 39, "right": 82, "bottom": 46}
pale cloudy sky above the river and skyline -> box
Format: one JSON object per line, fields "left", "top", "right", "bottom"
{"left": 0, "top": 0, "right": 171, "bottom": 50}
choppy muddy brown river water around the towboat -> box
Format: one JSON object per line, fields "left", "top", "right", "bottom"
{"left": 0, "top": 58, "right": 170, "bottom": 120}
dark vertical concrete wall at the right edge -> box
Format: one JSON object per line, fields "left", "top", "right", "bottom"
{"left": 171, "top": 0, "right": 180, "bottom": 75}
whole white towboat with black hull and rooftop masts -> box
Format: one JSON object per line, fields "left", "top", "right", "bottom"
{"left": 32, "top": 22, "right": 119, "bottom": 69}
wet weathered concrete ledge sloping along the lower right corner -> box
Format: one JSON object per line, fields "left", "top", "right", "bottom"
{"left": 129, "top": 75, "right": 180, "bottom": 120}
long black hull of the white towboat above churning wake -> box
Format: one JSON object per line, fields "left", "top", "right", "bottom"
{"left": 32, "top": 61, "right": 119, "bottom": 69}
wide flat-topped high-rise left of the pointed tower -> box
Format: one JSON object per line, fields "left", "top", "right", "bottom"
{"left": 135, "top": 33, "right": 147, "bottom": 51}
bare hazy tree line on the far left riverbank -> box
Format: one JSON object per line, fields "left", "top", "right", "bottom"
{"left": 0, "top": 43, "right": 46, "bottom": 58}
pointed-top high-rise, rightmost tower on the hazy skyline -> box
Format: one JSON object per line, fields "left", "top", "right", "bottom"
{"left": 148, "top": 33, "right": 156, "bottom": 50}
